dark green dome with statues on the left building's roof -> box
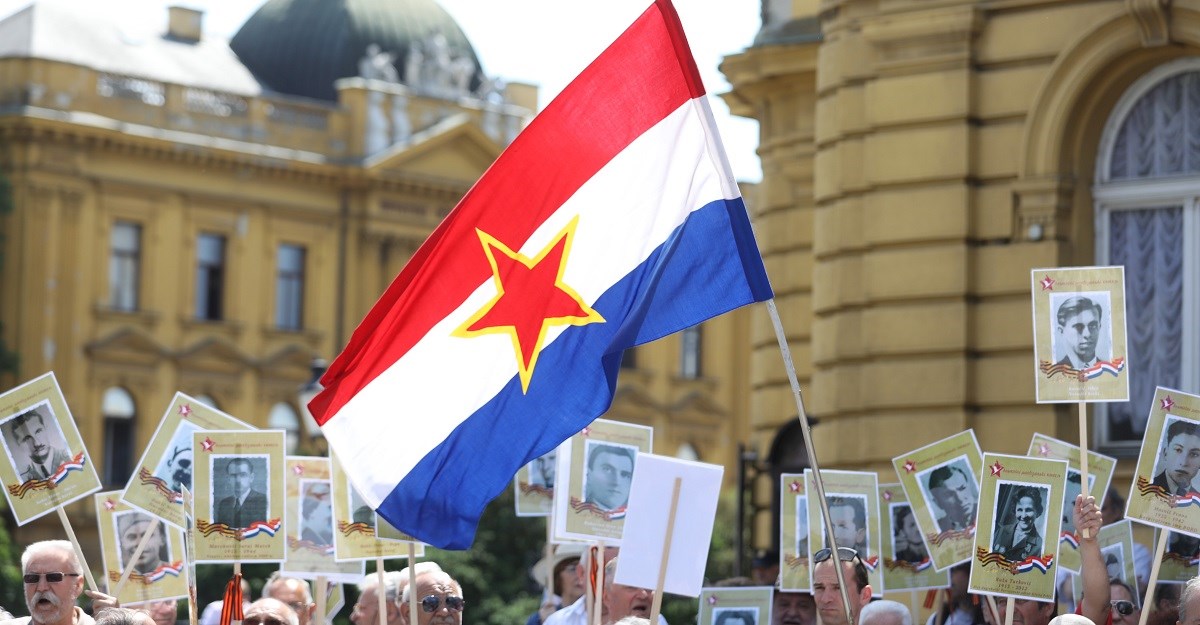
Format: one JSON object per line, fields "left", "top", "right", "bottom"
{"left": 229, "top": 0, "right": 482, "bottom": 101}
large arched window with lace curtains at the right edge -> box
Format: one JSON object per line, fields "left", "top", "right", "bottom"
{"left": 1093, "top": 58, "right": 1200, "bottom": 450}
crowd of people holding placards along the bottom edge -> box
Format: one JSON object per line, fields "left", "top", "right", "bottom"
{"left": 0, "top": 495, "right": 1200, "bottom": 625}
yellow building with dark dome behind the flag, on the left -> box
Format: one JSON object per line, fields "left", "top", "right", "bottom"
{"left": 0, "top": 0, "right": 750, "bottom": 567}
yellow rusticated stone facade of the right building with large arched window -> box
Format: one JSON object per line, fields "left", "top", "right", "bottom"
{"left": 721, "top": 0, "right": 1200, "bottom": 546}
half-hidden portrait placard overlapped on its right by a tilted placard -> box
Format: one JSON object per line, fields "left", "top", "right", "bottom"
{"left": 880, "top": 483, "right": 950, "bottom": 593}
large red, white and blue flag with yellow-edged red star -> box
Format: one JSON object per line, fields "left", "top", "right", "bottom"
{"left": 310, "top": 0, "right": 772, "bottom": 548}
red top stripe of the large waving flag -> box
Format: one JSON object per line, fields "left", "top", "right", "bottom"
{"left": 308, "top": 0, "right": 703, "bottom": 425}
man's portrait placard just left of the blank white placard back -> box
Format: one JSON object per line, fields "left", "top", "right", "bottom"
{"left": 553, "top": 419, "right": 654, "bottom": 546}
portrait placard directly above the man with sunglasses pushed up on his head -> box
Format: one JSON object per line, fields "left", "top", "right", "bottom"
{"left": 804, "top": 469, "right": 883, "bottom": 596}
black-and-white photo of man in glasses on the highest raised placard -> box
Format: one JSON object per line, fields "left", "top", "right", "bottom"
{"left": 1050, "top": 292, "right": 1112, "bottom": 371}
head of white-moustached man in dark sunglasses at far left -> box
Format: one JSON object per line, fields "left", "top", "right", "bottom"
{"left": 20, "top": 540, "right": 83, "bottom": 625}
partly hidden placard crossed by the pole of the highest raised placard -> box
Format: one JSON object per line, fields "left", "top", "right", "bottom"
{"left": 1026, "top": 433, "right": 1117, "bottom": 573}
